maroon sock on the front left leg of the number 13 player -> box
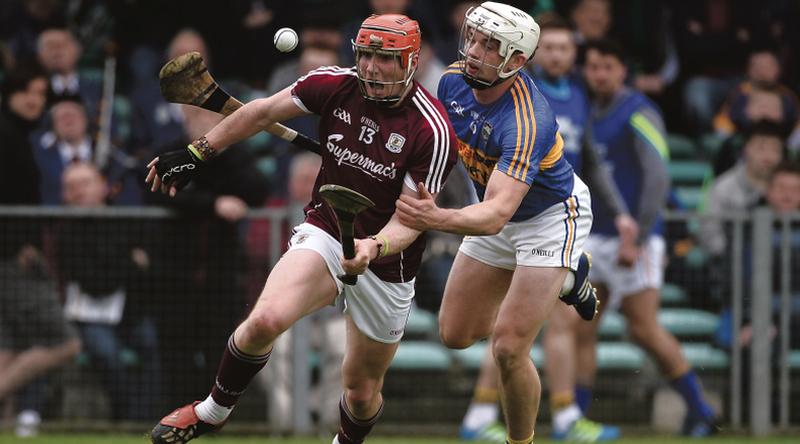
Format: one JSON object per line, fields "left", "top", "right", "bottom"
{"left": 211, "top": 335, "right": 272, "bottom": 407}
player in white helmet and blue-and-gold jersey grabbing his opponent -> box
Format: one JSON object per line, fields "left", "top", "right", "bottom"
{"left": 397, "top": 2, "right": 597, "bottom": 444}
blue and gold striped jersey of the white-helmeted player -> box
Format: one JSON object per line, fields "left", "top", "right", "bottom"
{"left": 438, "top": 63, "right": 574, "bottom": 222}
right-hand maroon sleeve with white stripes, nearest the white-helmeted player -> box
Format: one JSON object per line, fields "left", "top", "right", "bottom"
{"left": 408, "top": 87, "right": 458, "bottom": 193}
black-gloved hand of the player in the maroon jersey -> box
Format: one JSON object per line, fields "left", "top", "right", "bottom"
{"left": 145, "top": 148, "right": 205, "bottom": 196}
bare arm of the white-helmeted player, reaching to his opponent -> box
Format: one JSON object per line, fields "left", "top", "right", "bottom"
{"left": 395, "top": 171, "right": 530, "bottom": 236}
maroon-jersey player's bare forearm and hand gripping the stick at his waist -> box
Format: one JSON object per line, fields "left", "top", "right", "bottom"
{"left": 342, "top": 186, "right": 432, "bottom": 274}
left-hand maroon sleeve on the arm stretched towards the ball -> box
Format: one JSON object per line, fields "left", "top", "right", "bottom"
{"left": 292, "top": 66, "right": 354, "bottom": 114}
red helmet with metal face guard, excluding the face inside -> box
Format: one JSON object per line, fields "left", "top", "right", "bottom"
{"left": 353, "top": 14, "right": 421, "bottom": 102}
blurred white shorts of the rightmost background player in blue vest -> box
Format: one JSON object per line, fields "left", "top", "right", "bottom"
{"left": 584, "top": 234, "right": 666, "bottom": 309}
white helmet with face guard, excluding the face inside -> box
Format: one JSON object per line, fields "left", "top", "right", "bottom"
{"left": 459, "top": 2, "right": 539, "bottom": 88}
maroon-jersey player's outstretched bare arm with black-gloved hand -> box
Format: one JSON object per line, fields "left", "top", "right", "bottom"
{"left": 145, "top": 87, "right": 305, "bottom": 196}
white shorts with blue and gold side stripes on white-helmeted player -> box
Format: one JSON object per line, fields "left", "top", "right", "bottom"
{"left": 458, "top": 176, "right": 592, "bottom": 270}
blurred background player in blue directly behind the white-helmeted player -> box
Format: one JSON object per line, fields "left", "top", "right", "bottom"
{"left": 460, "top": 13, "right": 638, "bottom": 443}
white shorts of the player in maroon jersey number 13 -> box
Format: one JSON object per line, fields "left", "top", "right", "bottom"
{"left": 289, "top": 223, "right": 415, "bottom": 344}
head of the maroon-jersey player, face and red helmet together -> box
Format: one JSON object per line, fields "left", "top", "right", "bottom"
{"left": 352, "top": 14, "right": 420, "bottom": 105}
